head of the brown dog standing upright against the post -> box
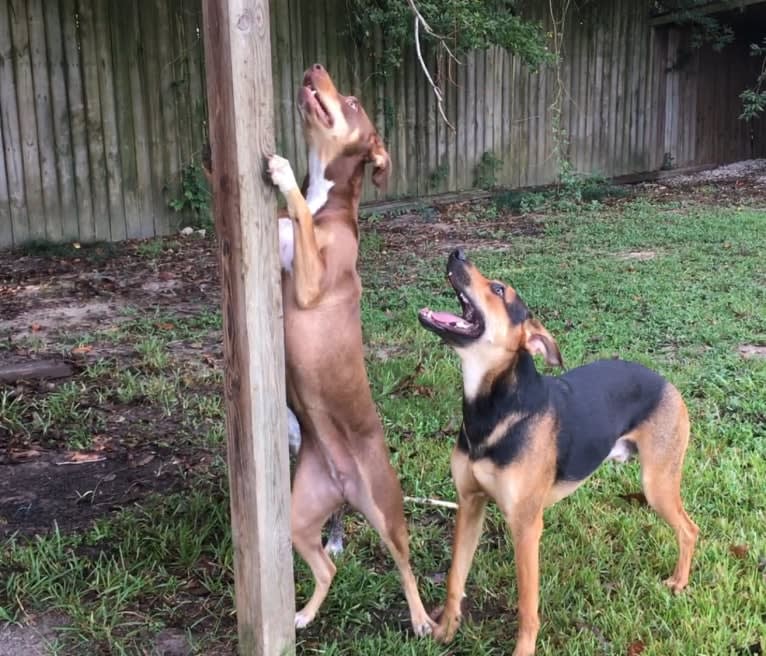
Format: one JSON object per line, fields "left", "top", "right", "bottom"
{"left": 298, "top": 64, "right": 391, "bottom": 187}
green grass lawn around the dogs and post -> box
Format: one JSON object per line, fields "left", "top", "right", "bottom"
{"left": 0, "top": 187, "right": 766, "bottom": 656}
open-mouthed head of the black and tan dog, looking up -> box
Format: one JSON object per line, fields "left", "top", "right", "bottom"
{"left": 418, "top": 249, "right": 562, "bottom": 384}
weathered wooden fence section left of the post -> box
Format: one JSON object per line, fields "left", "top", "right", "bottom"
{"left": 0, "top": 0, "right": 205, "bottom": 247}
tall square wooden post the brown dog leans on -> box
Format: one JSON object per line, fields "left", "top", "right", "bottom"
{"left": 203, "top": 0, "right": 295, "bottom": 656}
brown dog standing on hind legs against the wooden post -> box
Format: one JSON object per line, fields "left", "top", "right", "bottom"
{"left": 269, "top": 64, "right": 433, "bottom": 635}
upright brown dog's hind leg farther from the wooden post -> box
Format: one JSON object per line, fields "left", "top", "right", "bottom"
{"left": 347, "top": 453, "right": 435, "bottom": 636}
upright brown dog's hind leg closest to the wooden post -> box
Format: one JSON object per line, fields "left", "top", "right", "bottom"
{"left": 291, "top": 446, "right": 343, "bottom": 629}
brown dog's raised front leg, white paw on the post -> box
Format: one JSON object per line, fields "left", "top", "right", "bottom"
{"left": 269, "top": 155, "right": 326, "bottom": 309}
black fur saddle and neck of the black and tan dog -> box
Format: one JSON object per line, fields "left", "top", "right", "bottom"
{"left": 458, "top": 352, "right": 667, "bottom": 481}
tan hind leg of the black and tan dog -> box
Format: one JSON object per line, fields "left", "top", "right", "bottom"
{"left": 638, "top": 386, "right": 699, "bottom": 593}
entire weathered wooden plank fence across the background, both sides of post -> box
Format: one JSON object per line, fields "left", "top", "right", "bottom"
{"left": 0, "top": 0, "right": 766, "bottom": 247}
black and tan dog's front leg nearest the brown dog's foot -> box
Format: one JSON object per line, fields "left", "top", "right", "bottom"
{"left": 433, "top": 451, "right": 488, "bottom": 642}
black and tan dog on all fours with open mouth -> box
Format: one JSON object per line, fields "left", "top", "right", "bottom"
{"left": 419, "top": 250, "right": 699, "bottom": 656}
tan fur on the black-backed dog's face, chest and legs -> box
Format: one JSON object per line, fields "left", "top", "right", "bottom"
{"left": 434, "top": 263, "right": 699, "bottom": 656}
